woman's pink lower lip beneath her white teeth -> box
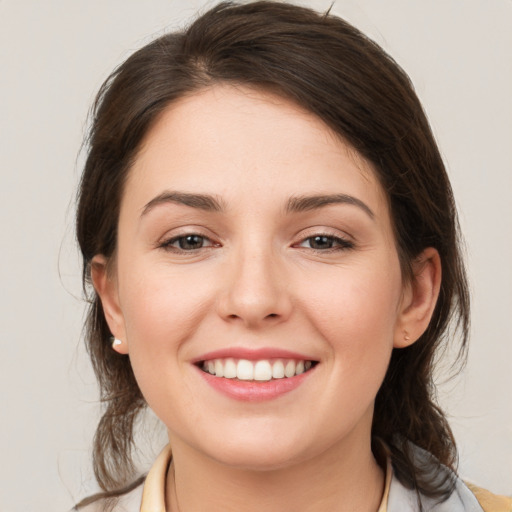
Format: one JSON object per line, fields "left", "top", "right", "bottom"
{"left": 197, "top": 368, "right": 314, "bottom": 402}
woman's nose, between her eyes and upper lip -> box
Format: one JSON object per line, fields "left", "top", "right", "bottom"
{"left": 218, "top": 243, "right": 292, "bottom": 329}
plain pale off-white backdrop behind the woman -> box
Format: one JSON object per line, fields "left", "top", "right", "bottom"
{"left": 0, "top": 0, "right": 512, "bottom": 512}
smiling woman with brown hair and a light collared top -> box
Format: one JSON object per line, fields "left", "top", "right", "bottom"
{"left": 77, "top": 2, "right": 509, "bottom": 512}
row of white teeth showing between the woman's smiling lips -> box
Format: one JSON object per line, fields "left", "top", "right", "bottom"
{"left": 197, "top": 357, "right": 318, "bottom": 382}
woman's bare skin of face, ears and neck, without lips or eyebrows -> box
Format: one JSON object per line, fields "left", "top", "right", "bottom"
{"left": 93, "top": 85, "right": 441, "bottom": 512}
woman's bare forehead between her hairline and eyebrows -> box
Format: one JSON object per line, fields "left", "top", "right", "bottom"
{"left": 126, "top": 85, "right": 385, "bottom": 213}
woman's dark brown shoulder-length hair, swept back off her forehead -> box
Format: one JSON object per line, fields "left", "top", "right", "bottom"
{"left": 77, "top": 1, "right": 469, "bottom": 499}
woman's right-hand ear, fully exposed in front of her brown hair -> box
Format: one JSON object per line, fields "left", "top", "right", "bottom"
{"left": 393, "top": 247, "right": 441, "bottom": 348}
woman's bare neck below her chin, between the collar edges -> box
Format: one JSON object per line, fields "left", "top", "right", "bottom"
{"left": 166, "top": 424, "right": 384, "bottom": 512}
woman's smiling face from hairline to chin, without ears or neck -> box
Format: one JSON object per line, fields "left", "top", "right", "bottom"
{"left": 97, "top": 86, "right": 416, "bottom": 468}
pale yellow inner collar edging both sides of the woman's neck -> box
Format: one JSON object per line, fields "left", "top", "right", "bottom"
{"left": 140, "top": 444, "right": 393, "bottom": 512}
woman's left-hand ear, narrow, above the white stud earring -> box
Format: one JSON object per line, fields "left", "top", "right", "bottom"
{"left": 91, "top": 254, "right": 128, "bottom": 354}
